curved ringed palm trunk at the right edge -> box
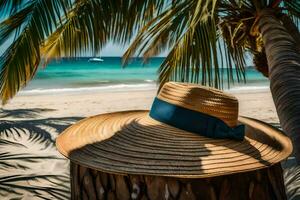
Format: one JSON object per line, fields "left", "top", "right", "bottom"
{"left": 258, "top": 11, "right": 300, "bottom": 163}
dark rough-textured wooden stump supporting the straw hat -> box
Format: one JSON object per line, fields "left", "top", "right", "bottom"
{"left": 71, "top": 162, "right": 286, "bottom": 200}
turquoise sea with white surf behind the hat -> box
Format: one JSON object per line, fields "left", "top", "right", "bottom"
{"left": 22, "top": 57, "right": 268, "bottom": 94}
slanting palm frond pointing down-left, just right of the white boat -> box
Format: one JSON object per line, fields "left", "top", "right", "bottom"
{"left": 123, "top": 3, "right": 193, "bottom": 63}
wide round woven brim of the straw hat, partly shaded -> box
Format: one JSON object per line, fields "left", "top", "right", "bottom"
{"left": 56, "top": 111, "right": 292, "bottom": 178}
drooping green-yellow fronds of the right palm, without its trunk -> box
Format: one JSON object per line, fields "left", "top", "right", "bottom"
{"left": 124, "top": 0, "right": 300, "bottom": 87}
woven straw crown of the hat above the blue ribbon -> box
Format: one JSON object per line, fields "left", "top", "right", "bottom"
{"left": 157, "top": 82, "right": 238, "bottom": 127}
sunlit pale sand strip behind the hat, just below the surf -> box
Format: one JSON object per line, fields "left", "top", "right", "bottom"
{"left": 2, "top": 89, "right": 278, "bottom": 122}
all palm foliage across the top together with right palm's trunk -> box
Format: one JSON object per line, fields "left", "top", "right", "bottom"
{"left": 0, "top": 0, "right": 300, "bottom": 161}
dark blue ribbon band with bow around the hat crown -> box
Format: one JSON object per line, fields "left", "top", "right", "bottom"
{"left": 150, "top": 98, "right": 245, "bottom": 141}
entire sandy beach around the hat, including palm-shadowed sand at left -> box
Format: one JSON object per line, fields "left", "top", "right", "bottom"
{"left": 0, "top": 89, "right": 300, "bottom": 199}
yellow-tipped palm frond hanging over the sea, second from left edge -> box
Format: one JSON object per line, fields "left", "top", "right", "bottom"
{"left": 42, "top": 1, "right": 111, "bottom": 61}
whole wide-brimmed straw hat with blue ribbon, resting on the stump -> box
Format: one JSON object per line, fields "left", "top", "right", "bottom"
{"left": 56, "top": 82, "right": 292, "bottom": 178}
